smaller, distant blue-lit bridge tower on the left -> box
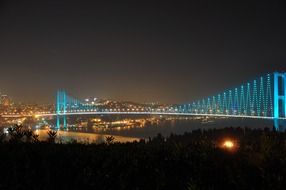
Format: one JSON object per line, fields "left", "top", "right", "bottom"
{"left": 56, "top": 90, "right": 67, "bottom": 129}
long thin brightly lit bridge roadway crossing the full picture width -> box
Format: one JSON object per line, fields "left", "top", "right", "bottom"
{"left": 1, "top": 112, "right": 286, "bottom": 120}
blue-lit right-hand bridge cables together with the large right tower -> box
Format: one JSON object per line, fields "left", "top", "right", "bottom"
{"left": 174, "top": 72, "right": 286, "bottom": 127}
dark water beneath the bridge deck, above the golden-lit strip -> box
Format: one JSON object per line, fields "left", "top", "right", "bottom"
{"left": 47, "top": 116, "right": 273, "bottom": 138}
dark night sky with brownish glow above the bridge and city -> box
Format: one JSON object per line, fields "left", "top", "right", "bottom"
{"left": 0, "top": 0, "right": 286, "bottom": 103}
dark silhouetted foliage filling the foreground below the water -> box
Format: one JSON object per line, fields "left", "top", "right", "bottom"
{"left": 0, "top": 128, "right": 286, "bottom": 190}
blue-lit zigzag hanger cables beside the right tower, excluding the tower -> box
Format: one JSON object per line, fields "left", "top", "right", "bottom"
{"left": 182, "top": 74, "right": 273, "bottom": 117}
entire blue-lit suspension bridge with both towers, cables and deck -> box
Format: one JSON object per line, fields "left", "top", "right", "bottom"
{"left": 42, "top": 72, "right": 286, "bottom": 129}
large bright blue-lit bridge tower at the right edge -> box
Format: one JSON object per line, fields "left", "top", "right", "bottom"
{"left": 273, "top": 72, "right": 286, "bottom": 130}
